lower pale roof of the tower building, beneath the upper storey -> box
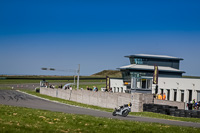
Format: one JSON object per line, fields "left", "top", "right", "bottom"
{"left": 118, "top": 64, "right": 185, "bottom": 73}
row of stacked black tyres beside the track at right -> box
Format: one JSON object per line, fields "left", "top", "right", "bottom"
{"left": 143, "top": 104, "right": 200, "bottom": 118}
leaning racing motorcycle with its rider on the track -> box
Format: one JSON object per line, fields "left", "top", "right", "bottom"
{"left": 112, "top": 103, "right": 132, "bottom": 117}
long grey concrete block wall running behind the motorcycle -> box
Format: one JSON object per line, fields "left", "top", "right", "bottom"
{"left": 40, "top": 87, "right": 153, "bottom": 112}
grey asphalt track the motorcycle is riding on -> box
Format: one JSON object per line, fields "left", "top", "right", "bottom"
{"left": 0, "top": 90, "right": 200, "bottom": 128}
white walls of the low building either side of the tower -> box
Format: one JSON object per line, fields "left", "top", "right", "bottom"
{"left": 110, "top": 77, "right": 200, "bottom": 103}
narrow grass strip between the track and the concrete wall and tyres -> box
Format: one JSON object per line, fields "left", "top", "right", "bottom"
{"left": 22, "top": 90, "right": 200, "bottom": 123}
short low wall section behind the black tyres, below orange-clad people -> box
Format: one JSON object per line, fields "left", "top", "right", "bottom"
{"left": 154, "top": 99, "right": 185, "bottom": 109}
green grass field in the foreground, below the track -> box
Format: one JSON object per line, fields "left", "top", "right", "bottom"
{"left": 0, "top": 105, "right": 199, "bottom": 133}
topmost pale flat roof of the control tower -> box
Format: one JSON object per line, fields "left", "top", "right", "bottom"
{"left": 125, "top": 54, "right": 183, "bottom": 60}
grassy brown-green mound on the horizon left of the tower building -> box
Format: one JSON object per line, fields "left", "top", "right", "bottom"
{"left": 91, "top": 70, "right": 122, "bottom": 78}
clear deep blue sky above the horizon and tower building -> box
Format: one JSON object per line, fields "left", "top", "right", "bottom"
{"left": 0, "top": 0, "right": 200, "bottom": 76}
